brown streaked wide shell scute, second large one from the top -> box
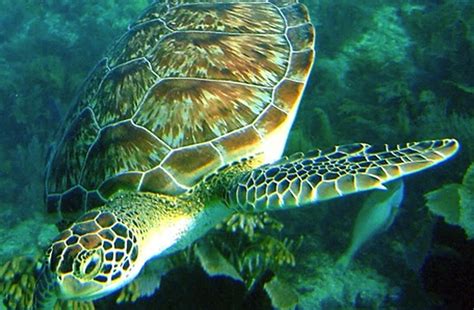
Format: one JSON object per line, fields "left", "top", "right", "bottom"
{"left": 150, "top": 32, "right": 289, "bottom": 87}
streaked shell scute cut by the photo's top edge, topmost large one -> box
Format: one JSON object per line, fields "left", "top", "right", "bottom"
{"left": 165, "top": 3, "right": 285, "bottom": 34}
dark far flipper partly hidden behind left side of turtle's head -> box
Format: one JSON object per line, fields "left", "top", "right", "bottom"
{"left": 33, "top": 265, "right": 58, "bottom": 310}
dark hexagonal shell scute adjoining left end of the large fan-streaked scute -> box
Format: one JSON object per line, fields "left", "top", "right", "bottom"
{"left": 93, "top": 59, "right": 157, "bottom": 127}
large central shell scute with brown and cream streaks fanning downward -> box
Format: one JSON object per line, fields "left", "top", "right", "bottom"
{"left": 134, "top": 79, "right": 272, "bottom": 148}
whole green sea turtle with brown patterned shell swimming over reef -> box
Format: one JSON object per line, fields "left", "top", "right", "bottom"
{"left": 34, "top": 0, "right": 458, "bottom": 308}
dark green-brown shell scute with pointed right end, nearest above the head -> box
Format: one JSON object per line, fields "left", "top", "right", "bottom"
{"left": 83, "top": 122, "right": 169, "bottom": 189}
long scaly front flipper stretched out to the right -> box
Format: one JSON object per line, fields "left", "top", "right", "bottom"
{"left": 228, "top": 139, "right": 459, "bottom": 211}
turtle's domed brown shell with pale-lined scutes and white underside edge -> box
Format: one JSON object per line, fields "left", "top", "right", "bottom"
{"left": 46, "top": 0, "right": 314, "bottom": 217}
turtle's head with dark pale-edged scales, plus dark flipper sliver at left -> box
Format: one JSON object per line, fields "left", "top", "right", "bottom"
{"left": 35, "top": 210, "right": 144, "bottom": 308}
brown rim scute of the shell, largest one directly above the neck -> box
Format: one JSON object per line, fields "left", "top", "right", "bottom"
{"left": 163, "top": 144, "right": 223, "bottom": 186}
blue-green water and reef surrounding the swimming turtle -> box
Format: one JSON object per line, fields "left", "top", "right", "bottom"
{"left": 0, "top": 0, "right": 474, "bottom": 309}
